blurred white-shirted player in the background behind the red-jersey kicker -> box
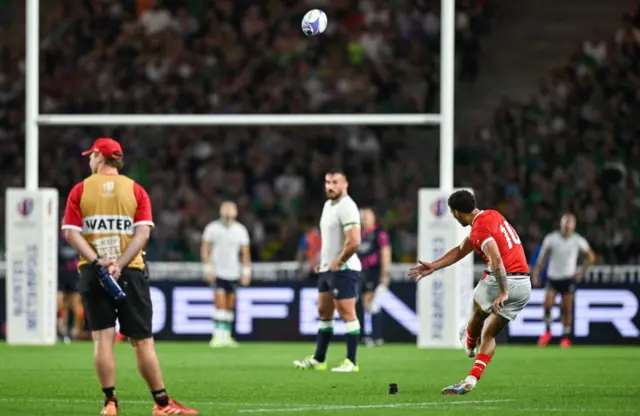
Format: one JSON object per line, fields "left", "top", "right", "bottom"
{"left": 533, "top": 214, "right": 596, "bottom": 348}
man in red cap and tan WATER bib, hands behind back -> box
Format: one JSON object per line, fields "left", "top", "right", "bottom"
{"left": 62, "top": 138, "right": 198, "bottom": 415}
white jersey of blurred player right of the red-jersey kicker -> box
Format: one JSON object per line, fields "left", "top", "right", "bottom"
{"left": 540, "top": 231, "right": 590, "bottom": 280}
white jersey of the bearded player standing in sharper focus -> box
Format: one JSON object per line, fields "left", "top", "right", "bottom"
{"left": 320, "top": 195, "right": 362, "bottom": 272}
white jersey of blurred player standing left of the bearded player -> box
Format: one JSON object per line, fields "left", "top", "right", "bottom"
{"left": 202, "top": 220, "right": 249, "bottom": 280}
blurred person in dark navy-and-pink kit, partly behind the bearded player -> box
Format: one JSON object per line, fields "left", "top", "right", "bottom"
{"left": 358, "top": 208, "right": 391, "bottom": 347}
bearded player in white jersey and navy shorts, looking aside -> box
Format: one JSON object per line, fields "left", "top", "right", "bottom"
{"left": 293, "top": 170, "right": 362, "bottom": 373}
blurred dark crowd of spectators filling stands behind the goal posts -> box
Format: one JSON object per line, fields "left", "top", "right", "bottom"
{"left": 0, "top": 0, "right": 640, "bottom": 263}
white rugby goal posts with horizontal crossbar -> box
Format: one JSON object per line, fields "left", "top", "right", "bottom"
{"left": 6, "top": 0, "right": 455, "bottom": 345}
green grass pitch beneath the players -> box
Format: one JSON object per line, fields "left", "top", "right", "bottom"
{"left": 0, "top": 342, "right": 640, "bottom": 416}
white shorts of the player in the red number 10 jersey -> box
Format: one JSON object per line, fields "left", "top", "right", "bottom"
{"left": 473, "top": 276, "right": 531, "bottom": 321}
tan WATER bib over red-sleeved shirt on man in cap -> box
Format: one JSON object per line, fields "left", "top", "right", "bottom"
{"left": 62, "top": 174, "right": 153, "bottom": 269}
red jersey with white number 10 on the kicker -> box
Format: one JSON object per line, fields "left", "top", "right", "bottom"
{"left": 469, "top": 209, "right": 529, "bottom": 278}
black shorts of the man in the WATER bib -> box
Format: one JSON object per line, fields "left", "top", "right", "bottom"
{"left": 78, "top": 266, "right": 153, "bottom": 340}
